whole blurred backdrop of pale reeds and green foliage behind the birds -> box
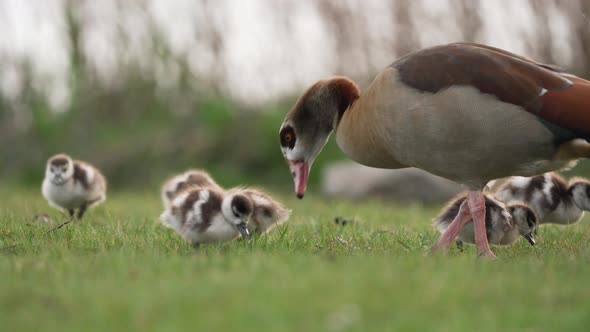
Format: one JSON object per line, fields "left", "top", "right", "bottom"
{"left": 0, "top": 0, "right": 590, "bottom": 197}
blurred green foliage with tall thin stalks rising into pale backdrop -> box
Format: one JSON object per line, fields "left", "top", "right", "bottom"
{"left": 0, "top": 4, "right": 342, "bottom": 190}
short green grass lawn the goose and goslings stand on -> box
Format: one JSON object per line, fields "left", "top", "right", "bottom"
{"left": 0, "top": 190, "right": 590, "bottom": 331}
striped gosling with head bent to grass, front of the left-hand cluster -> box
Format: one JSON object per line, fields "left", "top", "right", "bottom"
{"left": 160, "top": 187, "right": 253, "bottom": 247}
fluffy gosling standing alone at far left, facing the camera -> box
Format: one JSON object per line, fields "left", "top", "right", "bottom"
{"left": 41, "top": 154, "right": 107, "bottom": 219}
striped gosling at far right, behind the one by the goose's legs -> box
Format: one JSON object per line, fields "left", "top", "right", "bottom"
{"left": 496, "top": 172, "right": 590, "bottom": 225}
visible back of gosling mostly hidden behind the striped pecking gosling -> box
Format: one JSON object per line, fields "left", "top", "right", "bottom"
{"left": 162, "top": 169, "right": 223, "bottom": 207}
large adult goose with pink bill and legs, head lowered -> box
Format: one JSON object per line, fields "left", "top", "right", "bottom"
{"left": 280, "top": 43, "right": 590, "bottom": 257}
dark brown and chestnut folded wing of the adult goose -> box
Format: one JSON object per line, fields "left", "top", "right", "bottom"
{"left": 391, "top": 43, "right": 590, "bottom": 139}
